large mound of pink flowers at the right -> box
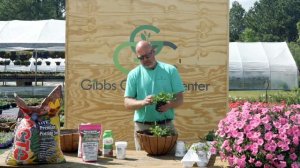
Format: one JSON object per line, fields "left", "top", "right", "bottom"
{"left": 212, "top": 102, "right": 300, "bottom": 168}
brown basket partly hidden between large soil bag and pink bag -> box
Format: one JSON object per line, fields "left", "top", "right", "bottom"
{"left": 60, "top": 129, "right": 79, "bottom": 153}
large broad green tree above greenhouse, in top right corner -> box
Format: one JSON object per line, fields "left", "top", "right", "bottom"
{"left": 245, "top": 0, "right": 300, "bottom": 41}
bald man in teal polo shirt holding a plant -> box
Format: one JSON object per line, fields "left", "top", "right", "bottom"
{"left": 124, "top": 41, "right": 185, "bottom": 150}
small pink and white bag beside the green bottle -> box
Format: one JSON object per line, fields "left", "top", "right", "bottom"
{"left": 78, "top": 124, "right": 101, "bottom": 162}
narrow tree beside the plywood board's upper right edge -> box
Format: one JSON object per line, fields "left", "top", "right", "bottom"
{"left": 229, "top": 1, "right": 245, "bottom": 42}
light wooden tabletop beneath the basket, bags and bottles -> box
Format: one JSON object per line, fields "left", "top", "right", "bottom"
{"left": 0, "top": 150, "right": 228, "bottom": 168}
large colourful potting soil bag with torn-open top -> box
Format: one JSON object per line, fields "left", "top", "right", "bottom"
{"left": 6, "top": 85, "right": 66, "bottom": 165}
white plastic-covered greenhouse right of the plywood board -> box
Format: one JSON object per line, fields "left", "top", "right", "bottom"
{"left": 229, "top": 42, "right": 299, "bottom": 90}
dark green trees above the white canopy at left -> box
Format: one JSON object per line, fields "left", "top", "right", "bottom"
{"left": 0, "top": 0, "right": 65, "bottom": 20}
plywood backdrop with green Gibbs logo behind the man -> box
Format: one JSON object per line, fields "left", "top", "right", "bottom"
{"left": 65, "top": 0, "right": 229, "bottom": 149}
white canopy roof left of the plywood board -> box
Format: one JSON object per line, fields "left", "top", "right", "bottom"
{"left": 0, "top": 19, "right": 66, "bottom": 51}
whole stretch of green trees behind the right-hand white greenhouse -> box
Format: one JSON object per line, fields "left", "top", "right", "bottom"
{"left": 229, "top": 0, "right": 300, "bottom": 69}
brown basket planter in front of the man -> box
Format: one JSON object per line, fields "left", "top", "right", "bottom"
{"left": 137, "top": 131, "right": 178, "bottom": 155}
